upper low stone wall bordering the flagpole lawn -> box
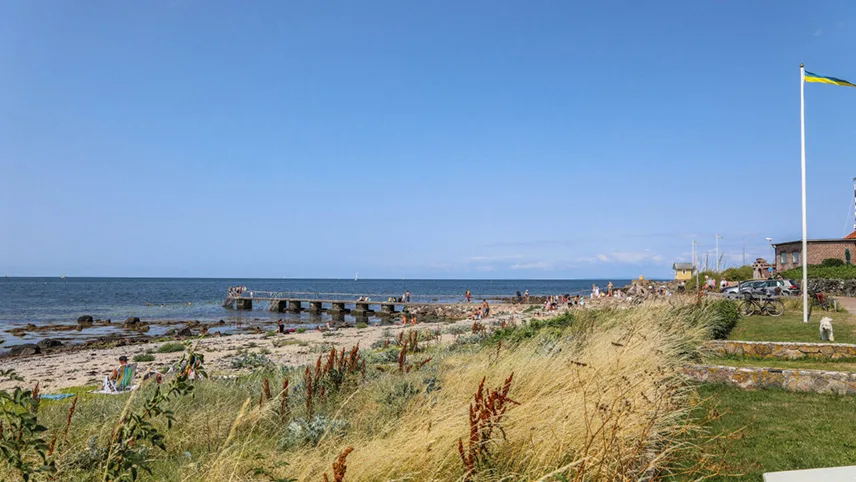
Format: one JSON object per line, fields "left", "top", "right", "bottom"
{"left": 704, "top": 335, "right": 856, "bottom": 360}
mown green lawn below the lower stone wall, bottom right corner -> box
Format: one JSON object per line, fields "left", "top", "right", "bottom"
{"left": 699, "top": 384, "right": 856, "bottom": 481}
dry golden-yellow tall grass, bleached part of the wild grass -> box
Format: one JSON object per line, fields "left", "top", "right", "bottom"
{"left": 282, "top": 307, "right": 716, "bottom": 480}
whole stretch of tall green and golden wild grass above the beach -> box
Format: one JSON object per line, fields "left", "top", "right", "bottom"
{"left": 5, "top": 303, "right": 719, "bottom": 481}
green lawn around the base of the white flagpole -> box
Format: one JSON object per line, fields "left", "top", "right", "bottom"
{"left": 728, "top": 310, "right": 856, "bottom": 343}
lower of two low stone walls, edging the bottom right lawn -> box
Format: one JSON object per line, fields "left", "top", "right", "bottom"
{"left": 684, "top": 365, "right": 856, "bottom": 395}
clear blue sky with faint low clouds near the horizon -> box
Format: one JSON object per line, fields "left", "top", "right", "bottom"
{"left": 0, "top": 0, "right": 856, "bottom": 279}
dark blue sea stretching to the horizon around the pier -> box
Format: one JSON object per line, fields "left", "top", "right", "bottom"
{"left": 0, "top": 277, "right": 630, "bottom": 346}
